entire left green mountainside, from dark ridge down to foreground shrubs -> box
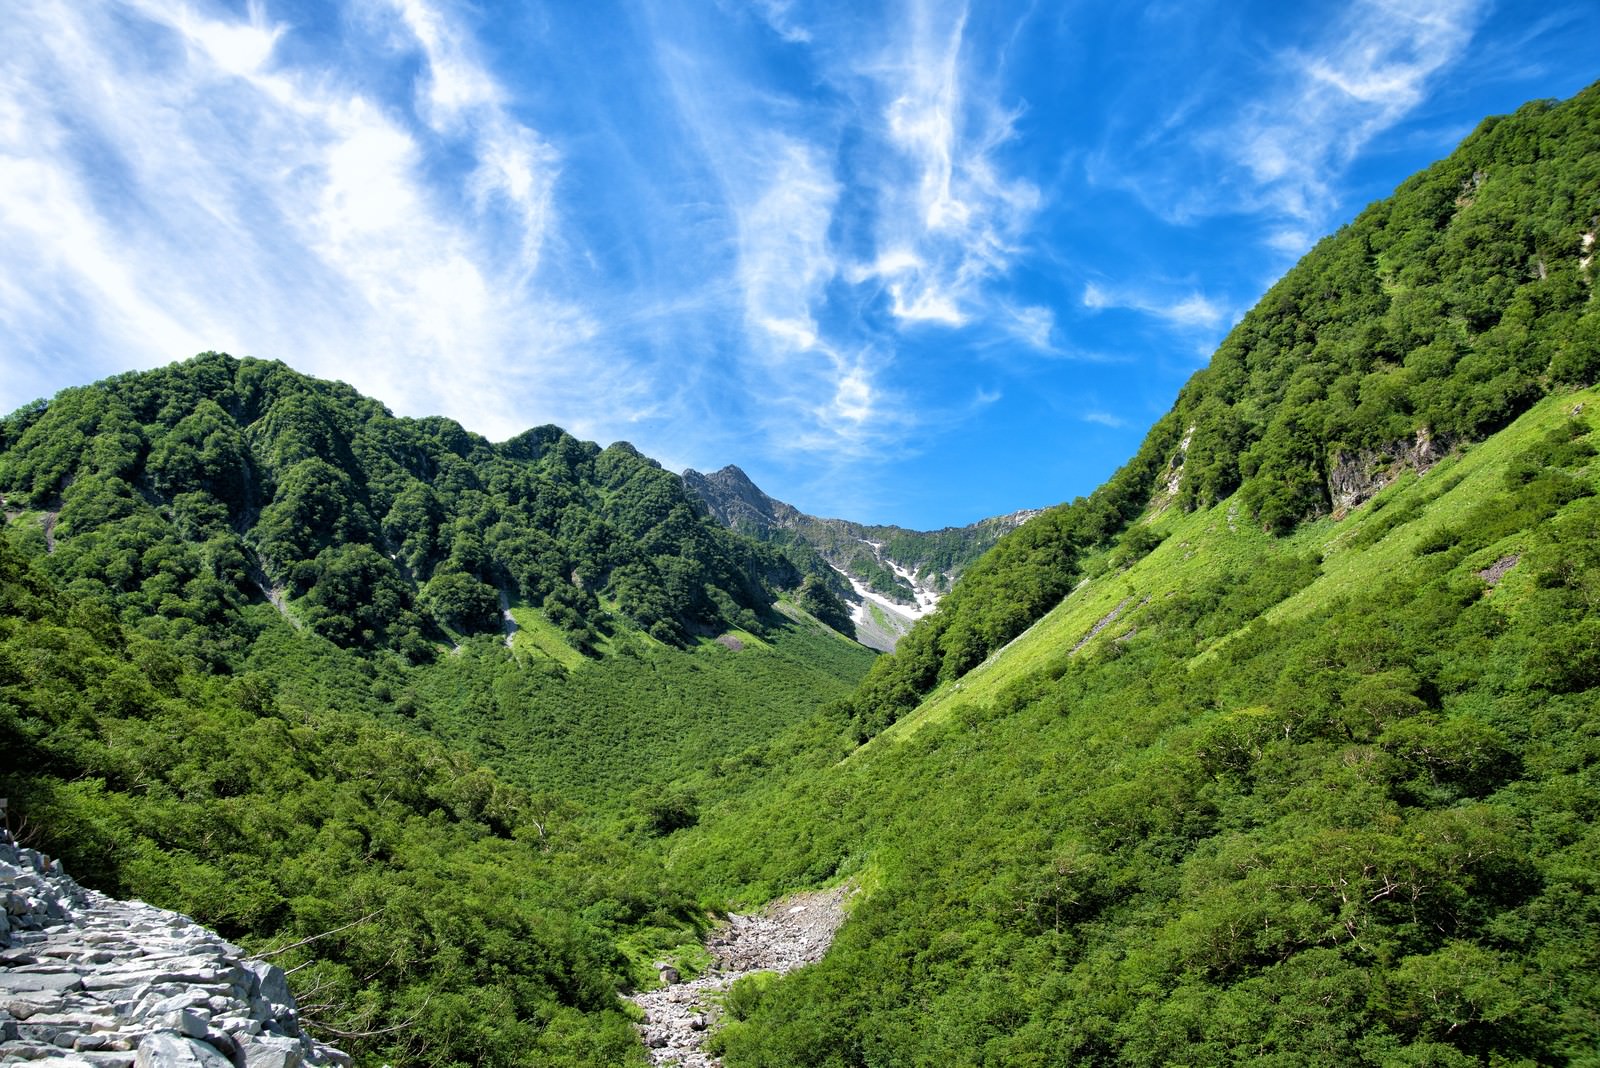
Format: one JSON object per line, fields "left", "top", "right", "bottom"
{"left": 0, "top": 353, "right": 872, "bottom": 1066}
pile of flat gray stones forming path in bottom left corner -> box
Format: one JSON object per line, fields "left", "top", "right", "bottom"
{"left": 0, "top": 831, "right": 350, "bottom": 1068}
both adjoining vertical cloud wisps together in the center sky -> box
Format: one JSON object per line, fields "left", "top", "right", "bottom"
{"left": 636, "top": 0, "right": 1054, "bottom": 459}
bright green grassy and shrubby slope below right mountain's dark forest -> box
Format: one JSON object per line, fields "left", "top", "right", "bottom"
{"left": 672, "top": 383, "right": 1600, "bottom": 1065}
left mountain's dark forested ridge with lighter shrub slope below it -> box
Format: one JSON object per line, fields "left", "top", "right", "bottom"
{"left": 0, "top": 353, "right": 870, "bottom": 793}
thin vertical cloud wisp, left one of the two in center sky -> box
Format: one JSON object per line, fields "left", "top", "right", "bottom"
{"left": 656, "top": 19, "right": 901, "bottom": 460}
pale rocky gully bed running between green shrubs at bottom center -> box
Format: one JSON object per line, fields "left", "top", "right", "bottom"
{"left": 629, "top": 884, "right": 854, "bottom": 1068}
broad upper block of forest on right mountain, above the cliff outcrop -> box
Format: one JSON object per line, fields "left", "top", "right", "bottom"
{"left": 1174, "top": 88, "right": 1600, "bottom": 532}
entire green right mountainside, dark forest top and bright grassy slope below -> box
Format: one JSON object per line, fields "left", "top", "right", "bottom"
{"left": 670, "top": 81, "right": 1600, "bottom": 1068}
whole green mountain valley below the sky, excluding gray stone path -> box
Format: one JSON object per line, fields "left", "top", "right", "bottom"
{"left": 0, "top": 86, "right": 1600, "bottom": 1068}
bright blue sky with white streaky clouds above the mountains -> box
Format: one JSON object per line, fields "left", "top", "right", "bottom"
{"left": 0, "top": 0, "right": 1600, "bottom": 528}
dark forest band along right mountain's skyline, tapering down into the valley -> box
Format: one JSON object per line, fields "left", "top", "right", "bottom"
{"left": 825, "top": 86, "right": 1600, "bottom": 739}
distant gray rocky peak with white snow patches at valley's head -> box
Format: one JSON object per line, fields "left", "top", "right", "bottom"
{"left": 683, "top": 464, "right": 1038, "bottom": 651}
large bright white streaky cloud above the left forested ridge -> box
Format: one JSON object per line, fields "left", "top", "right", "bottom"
{"left": 0, "top": 0, "right": 634, "bottom": 436}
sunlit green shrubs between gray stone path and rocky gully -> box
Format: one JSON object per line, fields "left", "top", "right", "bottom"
{"left": 0, "top": 540, "right": 675, "bottom": 1068}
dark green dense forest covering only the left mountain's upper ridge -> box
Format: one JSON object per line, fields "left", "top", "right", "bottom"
{"left": 0, "top": 353, "right": 825, "bottom": 660}
